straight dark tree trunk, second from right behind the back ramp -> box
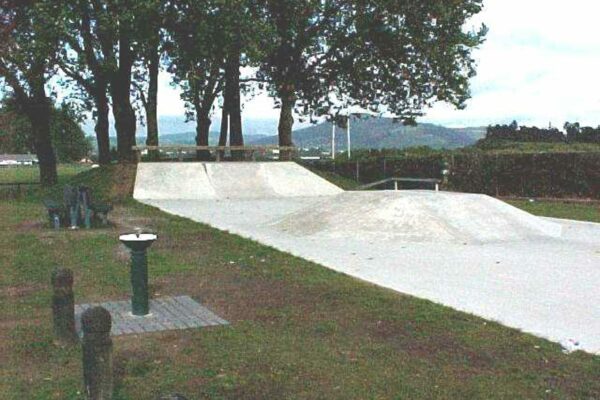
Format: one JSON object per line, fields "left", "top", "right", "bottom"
{"left": 225, "top": 48, "right": 244, "bottom": 160}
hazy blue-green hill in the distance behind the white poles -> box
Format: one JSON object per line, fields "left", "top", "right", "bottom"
{"left": 247, "top": 118, "right": 486, "bottom": 150}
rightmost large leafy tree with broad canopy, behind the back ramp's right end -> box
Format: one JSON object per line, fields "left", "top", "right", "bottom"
{"left": 256, "top": 0, "right": 486, "bottom": 157}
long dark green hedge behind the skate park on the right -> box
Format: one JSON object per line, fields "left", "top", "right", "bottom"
{"left": 314, "top": 152, "right": 600, "bottom": 199}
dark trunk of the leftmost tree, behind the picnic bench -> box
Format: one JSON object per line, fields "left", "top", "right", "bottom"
{"left": 27, "top": 81, "right": 58, "bottom": 186}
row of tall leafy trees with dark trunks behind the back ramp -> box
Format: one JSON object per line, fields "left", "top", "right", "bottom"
{"left": 0, "top": 0, "right": 486, "bottom": 182}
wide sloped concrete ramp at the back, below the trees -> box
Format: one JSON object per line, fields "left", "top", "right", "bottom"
{"left": 133, "top": 162, "right": 342, "bottom": 200}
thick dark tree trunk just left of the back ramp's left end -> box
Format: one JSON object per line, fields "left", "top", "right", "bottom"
{"left": 111, "top": 29, "right": 136, "bottom": 162}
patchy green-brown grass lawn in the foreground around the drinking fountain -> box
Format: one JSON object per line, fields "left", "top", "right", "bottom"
{"left": 0, "top": 166, "right": 600, "bottom": 400}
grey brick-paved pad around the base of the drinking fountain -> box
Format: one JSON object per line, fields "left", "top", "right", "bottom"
{"left": 75, "top": 296, "right": 228, "bottom": 336}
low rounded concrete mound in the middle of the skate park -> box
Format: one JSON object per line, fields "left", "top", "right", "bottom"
{"left": 272, "top": 190, "right": 561, "bottom": 244}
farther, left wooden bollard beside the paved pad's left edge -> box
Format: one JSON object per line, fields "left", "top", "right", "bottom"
{"left": 52, "top": 268, "right": 78, "bottom": 344}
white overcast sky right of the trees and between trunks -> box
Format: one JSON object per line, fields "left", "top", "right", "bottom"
{"left": 158, "top": 0, "right": 600, "bottom": 127}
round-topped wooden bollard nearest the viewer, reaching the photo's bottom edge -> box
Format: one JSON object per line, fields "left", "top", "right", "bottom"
{"left": 81, "top": 307, "right": 113, "bottom": 400}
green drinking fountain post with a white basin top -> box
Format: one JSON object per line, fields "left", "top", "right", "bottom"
{"left": 119, "top": 232, "right": 157, "bottom": 316}
